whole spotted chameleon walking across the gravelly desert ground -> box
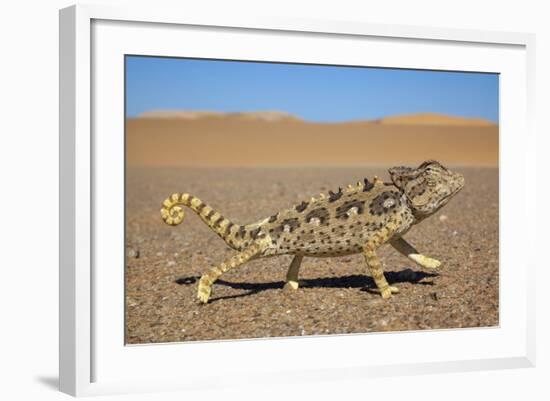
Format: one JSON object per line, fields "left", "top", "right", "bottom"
{"left": 160, "top": 160, "right": 464, "bottom": 303}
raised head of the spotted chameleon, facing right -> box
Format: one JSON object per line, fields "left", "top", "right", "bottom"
{"left": 389, "top": 160, "right": 464, "bottom": 218}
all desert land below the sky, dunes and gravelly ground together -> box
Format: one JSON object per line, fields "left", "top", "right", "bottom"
{"left": 125, "top": 111, "right": 499, "bottom": 344}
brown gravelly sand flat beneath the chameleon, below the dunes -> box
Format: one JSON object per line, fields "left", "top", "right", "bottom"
{"left": 126, "top": 167, "right": 499, "bottom": 344}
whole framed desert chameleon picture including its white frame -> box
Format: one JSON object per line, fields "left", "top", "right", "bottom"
{"left": 60, "top": 6, "right": 535, "bottom": 395}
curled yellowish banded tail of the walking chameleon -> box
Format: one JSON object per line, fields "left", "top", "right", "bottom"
{"left": 160, "top": 193, "right": 246, "bottom": 249}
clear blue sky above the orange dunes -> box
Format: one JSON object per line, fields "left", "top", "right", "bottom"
{"left": 126, "top": 56, "right": 498, "bottom": 122}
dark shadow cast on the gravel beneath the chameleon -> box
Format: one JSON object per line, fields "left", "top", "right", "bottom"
{"left": 176, "top": 269, "right": 439, "bottom": 303}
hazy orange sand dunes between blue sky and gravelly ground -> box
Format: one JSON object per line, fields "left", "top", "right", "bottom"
{"left": 126, "top": 112, "right": 498, "bottom": 166}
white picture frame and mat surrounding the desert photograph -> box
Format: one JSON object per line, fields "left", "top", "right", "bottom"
{"left": 59, "top": 5, "right": 536, "bottom": 396}
